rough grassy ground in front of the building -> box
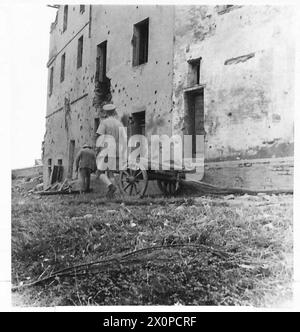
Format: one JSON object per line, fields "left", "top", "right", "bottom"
{"left": 12, "top": 179, "right": 293, "bottom": 307}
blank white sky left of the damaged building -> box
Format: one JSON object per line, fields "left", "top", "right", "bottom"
{"left": 9, "top": 4, "right": 56, "bottom": 168}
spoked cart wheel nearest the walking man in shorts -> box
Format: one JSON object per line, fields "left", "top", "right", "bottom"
{"left": 120, "top": 168, "right": 148, "bottom": 197}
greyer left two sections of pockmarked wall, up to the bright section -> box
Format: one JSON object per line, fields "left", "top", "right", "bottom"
{"left": 43, "top": 5, "right": 174, "bottom": 185}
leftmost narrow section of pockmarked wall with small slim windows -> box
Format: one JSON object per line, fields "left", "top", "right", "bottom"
{"left": 43, "top": 6, "right": 95, "bottom": 185}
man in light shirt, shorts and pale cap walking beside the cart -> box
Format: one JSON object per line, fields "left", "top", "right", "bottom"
{"left": 96, "top": 104, "right": 127, "bottom": 198}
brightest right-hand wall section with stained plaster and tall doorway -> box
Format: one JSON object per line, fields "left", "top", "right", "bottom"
{"left": 173, "top": 6, "right": 295, "bottom": 189}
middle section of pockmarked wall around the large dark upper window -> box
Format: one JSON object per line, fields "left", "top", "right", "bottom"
{"left": 91, "top": 5, "right": 174, "bottom": 136}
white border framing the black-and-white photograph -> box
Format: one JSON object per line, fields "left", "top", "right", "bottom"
{"left": 0, "top": 0, "right": 300, "bottom": 312}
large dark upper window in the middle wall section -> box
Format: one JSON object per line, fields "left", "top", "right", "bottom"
{"left": 132, "top": 18, "right": 149, "bottom": 66}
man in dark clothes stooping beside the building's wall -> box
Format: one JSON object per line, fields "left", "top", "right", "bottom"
{"left": 75, "top": 144, "right": 97, "bottom": 193}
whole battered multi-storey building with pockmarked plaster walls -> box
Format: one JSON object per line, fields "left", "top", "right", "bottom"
{"left": 43, "top": 5, "right": 295, "bottom": 190}
